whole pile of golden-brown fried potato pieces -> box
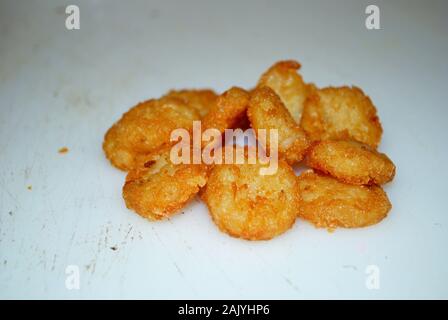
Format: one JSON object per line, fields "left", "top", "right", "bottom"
{"left": 103, "top": 60, "right": 395, "bottom": 240}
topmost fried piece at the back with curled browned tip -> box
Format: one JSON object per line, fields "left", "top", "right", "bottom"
{"left": 257, "top": 60, "right": 315, "bottom": 123}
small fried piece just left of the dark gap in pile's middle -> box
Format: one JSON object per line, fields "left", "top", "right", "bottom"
{"left": 202, "top": 87, "right": 249, "bottom": 133}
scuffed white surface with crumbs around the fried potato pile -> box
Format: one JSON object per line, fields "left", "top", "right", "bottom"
{"left": 0, "top": 0, "right": 448, "bottom": 299}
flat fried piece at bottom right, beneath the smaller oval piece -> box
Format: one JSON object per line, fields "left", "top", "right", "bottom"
{"left": 298, "top": 170, "right": 392, "bottom": 230}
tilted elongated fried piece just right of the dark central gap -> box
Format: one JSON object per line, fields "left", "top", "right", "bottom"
{"left": 247, "top": 87, "right": 309, "bottom": 165}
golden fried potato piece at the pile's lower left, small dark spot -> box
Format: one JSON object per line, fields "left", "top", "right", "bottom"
{"left": 123, "top": 149, "right": 208, "bottom": 220}
